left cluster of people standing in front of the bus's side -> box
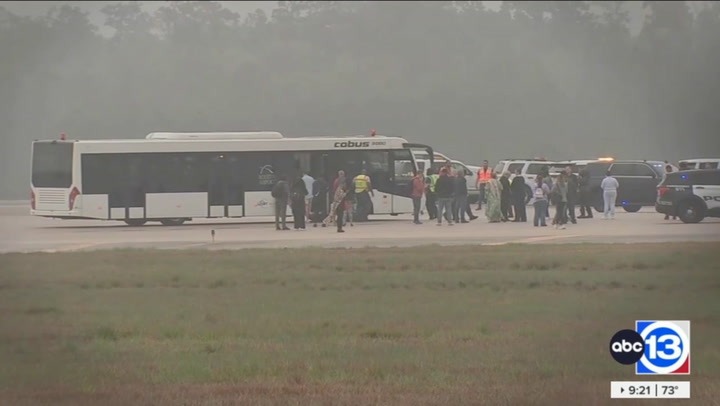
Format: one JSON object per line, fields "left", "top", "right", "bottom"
{"left": 271, "top": 170, "right": 374, "bottom": 233}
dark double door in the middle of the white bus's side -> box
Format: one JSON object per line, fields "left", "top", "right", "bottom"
{"left": 208, "top": 154, "right": 244, "bottom": 217}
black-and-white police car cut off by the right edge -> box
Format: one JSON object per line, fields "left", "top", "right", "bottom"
{"left": 655, "top": 169, "right": 720, "bottom": 223}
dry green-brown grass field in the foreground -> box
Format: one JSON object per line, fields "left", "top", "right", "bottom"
{"left": 0, "top": 243, "right": 720, "bottom": 405}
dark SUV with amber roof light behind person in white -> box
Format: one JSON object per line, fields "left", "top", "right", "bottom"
{"left": 585, "top": 161, "right": 665, "bottom": 213}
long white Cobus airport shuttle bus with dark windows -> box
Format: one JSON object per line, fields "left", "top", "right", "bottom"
{"left": 31, "top": 132, "right": 432, "bottom": 226}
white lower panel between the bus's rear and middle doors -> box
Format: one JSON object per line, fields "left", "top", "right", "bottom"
{"left": 145, "top": 193, "right": 208, "bottom": 219}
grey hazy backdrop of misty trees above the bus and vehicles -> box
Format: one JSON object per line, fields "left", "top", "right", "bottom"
{"left": 0, "top": 1, "right": 720, "bottom": 199}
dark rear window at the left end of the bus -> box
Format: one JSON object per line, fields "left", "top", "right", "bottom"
{"left": 32, "top": 142, "right": 73, "bottom": 188}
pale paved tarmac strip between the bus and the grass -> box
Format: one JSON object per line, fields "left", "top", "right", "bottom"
{"left": 0, "top": 203, "right": 720, "bottom": 252}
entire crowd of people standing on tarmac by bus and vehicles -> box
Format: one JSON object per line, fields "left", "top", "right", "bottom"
{"left": 272, "top": 161, "right": 619, "bottom": 233}
